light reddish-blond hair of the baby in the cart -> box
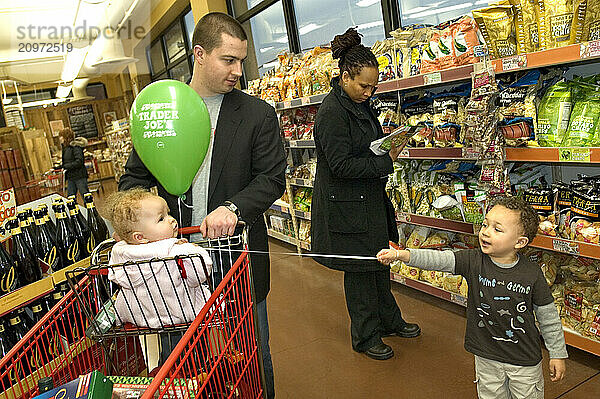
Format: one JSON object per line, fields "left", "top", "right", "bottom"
{"left": 102, "top": 187, "right": 155, "bottom": 242}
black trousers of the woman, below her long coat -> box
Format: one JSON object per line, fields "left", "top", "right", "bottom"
{"left": 344, "top": 270, "right": 406, "bottom": 352}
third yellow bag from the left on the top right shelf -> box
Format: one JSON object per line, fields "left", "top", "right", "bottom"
{"left": 544, "top": 0, "right": 587, "bottom": 49}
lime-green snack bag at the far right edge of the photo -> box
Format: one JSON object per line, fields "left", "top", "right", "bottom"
{"left": 562, "top": 90, "right": 600, "bottom": 147}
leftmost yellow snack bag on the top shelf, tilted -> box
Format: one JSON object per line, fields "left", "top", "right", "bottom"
{"left": 473, "top": 5, "right": 517, "bottom": 58}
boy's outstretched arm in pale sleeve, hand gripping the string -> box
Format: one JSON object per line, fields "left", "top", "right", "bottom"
{"left": 377, "top": 248, "right": 456, "bottom": 274}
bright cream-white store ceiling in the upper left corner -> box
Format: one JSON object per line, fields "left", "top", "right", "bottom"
{"left": 0, "top": 0, "right": 150, "bottom": 86}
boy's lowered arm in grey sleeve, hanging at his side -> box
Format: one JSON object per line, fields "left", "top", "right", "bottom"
{"left": 533, "top": 303, "right": 569, "bottom": 381}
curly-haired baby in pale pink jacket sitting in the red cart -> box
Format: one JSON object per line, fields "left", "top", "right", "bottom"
{"left": 105, "top": 188, "right": 212, "bottom": 329}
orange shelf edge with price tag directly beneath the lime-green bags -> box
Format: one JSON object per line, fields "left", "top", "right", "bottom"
{"left": 506, "top": 147, "right": 600, "bottom": 163}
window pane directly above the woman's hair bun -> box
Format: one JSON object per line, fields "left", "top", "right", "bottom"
{"left": 294, "top": 0, "right": 386, "bottom": 50}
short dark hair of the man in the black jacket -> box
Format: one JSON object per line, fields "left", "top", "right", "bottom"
{"left": 192, "top": 12, "right": 248, "bottom": 53}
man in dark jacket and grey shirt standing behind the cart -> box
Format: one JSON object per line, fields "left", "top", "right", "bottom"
{"left": 119, "top": 13, "right": 286, "bottom": 398}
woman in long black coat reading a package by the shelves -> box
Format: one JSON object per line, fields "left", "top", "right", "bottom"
{"left": 311, "top": 28, "right": 421, "bottom": 360}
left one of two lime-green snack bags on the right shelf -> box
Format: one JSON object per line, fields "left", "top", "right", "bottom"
{"left": 536, "top": 82, "right": 572, "bottom": 147}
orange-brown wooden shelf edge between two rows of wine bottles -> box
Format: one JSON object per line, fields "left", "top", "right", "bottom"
{"left": 0, "top": 257, "right": 90, "bottom": 317}
